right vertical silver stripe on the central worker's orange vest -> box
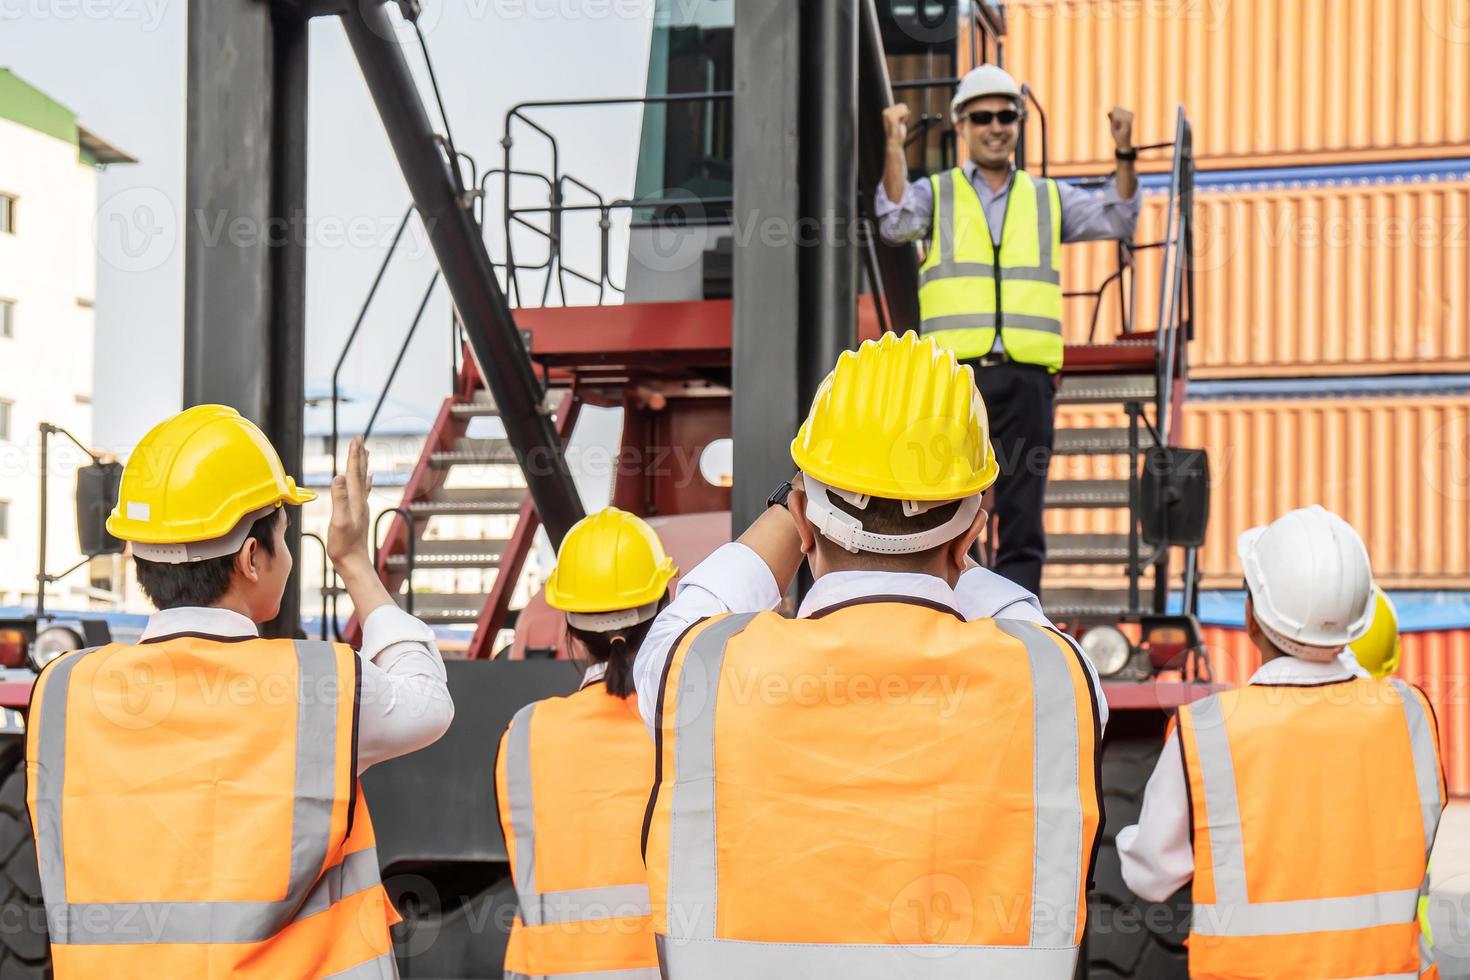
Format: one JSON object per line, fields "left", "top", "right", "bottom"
{"left": 995, "top": 620, "right": 1091, "bottom": 946}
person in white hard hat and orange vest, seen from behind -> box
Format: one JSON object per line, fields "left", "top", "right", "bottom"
{"left": 1117, "top": 505, "right": 1446, "bottom": 979}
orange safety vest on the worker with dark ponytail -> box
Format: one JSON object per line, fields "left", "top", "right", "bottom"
{"left": 495, "top": 683, "right": 659, "bottom": 980}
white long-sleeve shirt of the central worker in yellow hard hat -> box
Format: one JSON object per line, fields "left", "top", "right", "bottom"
{"left": 634, "top": 541, "right": 1107, "bottom": 732}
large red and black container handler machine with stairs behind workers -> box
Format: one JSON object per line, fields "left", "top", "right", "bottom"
{"left": 0, "top": 0, "right": 1213, "bottom": 979}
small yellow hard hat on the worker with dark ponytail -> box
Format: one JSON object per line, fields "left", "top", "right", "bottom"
{"left": 547, "top": 507, "right": 679, "bottom": 632}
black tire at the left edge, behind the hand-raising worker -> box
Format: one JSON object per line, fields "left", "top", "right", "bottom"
{"left": 0, "top": 738, "right": 51, "bottom": 980}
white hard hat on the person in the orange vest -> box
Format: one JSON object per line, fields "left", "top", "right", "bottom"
{"left": 1236, "top": 504, "right": 1374, "bottom": 661}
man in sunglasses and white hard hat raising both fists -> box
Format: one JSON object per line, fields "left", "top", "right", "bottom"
{"left": 875, "top": 65, "right": 1139, "bottom": 592}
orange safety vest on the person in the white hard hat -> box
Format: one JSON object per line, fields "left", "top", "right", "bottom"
{"left": 1179, "top": 679, "right": 1445, "bottom": 980}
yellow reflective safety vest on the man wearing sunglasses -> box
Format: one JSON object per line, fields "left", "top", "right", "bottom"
{"left": 919, "top": 167, "right": 1063, "bottom": 373}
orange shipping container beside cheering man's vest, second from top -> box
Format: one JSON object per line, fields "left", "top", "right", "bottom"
{"left": 1063, "top": 167, "right": 1470, "bottom": 378}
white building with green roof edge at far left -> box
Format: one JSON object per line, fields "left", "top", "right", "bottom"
{"left": 0, "top": 68, "right": 134, "bottom": 608}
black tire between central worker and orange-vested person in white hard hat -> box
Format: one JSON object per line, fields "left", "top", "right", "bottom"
{"left": 1086, "top": 711, "right": 1191, "bottom": 980}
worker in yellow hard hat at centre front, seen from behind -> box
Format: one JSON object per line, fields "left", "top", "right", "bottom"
{"left": 634, "top": 332, "right": 1104, "bottom": 980}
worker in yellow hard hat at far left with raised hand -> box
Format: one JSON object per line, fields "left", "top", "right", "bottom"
{"left": 26, "top": 406, "right": 453, "bottom": 980}
